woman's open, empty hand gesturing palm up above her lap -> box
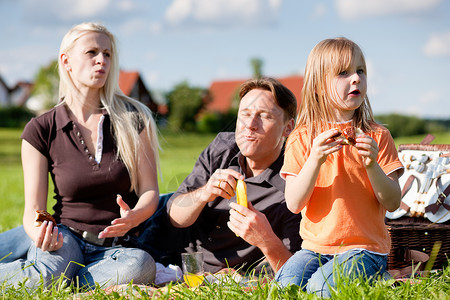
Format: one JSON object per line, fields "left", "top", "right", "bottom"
{"left": 98, "top": 195, "right": 139, "bottom": 239}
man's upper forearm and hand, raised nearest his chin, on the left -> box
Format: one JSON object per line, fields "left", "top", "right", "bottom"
{"left": 169, "top": 169, "right": 243, "bottom": 228}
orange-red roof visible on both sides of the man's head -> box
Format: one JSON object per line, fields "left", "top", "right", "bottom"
{"left": 206, "top": 75, "right": 303, "bottom": 113}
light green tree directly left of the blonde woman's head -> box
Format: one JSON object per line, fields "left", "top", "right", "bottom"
{"left": 32, "top": 60, "right": 59, "bottom": 108}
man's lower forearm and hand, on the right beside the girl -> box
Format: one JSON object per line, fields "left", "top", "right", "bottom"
{"left": 228, "top": 202, "right": 292, "bottom": 272}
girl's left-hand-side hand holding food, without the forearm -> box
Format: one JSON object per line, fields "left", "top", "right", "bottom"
{"left": 309, "top": 129, "right": 342, "bottom": 165}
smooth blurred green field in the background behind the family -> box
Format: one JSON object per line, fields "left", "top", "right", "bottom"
{"left": 0, "top": 128, "right": 450, "bottom": 232}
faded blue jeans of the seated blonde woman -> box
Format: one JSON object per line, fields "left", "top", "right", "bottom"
{"left": 0, "top": 225, "right": 156, "bottom": 289}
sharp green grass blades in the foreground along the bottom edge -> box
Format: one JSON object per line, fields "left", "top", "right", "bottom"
{"left": 0, "top": 268, "right": 450, "bottom": 300}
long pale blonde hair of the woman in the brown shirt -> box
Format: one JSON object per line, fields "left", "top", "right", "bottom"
{"left": 58, "top": 22, "right": 159, "bottom": 191}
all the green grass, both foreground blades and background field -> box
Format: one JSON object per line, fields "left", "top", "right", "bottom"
{"left": 0, "top": 128, "right": 450, "bottom": 300}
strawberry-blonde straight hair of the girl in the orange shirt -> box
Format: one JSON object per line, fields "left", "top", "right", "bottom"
{"left": 296, "top": 37, "right": 374, "bottom": 149}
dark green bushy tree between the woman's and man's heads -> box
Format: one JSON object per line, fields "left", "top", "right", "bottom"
{"left": 167, "top": 81, "right": 207, "bottom": 131}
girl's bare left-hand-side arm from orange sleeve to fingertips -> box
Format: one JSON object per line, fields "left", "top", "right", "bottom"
{"left": 285, "top": 129, "right": 342, "bottom": 214}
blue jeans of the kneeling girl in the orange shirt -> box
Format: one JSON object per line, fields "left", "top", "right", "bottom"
{"left": 275, "top": 249, "right": 388, "bottom": 298}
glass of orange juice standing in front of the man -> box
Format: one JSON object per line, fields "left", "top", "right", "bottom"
{"left": 181, "top": 252, "right": 205, "bottom": 287}
